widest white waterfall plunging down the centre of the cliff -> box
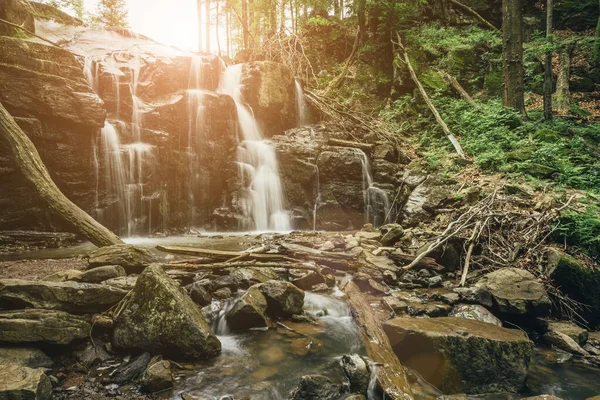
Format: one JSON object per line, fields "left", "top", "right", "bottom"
{"left": 219, "top": 64, "right": 290, "bottom": 231}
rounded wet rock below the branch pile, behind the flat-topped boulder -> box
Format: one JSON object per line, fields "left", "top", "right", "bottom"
{"left": 475, "top": 268, "right": 551, "bottom": 316}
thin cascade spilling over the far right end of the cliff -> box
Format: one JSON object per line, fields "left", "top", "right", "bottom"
{"left": 352, "top": 149, "right": 392, "bottom": 226}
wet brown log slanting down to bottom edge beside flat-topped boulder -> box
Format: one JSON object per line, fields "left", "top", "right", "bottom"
{"left": 342, "top": 280, "right": 414, "bottom": 400}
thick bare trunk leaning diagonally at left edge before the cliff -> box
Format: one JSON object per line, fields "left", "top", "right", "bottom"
{"left": 0, "top": 103, "right": 123, "bottom": 247}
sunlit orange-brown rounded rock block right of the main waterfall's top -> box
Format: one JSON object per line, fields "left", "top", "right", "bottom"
{"left": 242, "top": 61, "right": 297, "bottom": 137}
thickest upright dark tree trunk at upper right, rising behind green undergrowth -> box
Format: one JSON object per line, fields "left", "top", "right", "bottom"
{"left": 502, "top": 0, "right": 525, "bottom": 114}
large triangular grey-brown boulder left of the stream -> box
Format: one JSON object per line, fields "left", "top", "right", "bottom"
{"left": 113, "top": 264, "right": 221, "bottom": 360}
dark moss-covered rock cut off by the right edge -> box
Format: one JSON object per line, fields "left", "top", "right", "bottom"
{"left": 546, "top": 248, "right": 600, "bottom": 327}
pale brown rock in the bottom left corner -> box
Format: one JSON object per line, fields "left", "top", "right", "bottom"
{"left": 0, "top": 364, "right": 52, "bottom": 400}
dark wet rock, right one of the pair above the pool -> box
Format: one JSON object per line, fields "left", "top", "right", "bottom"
{"left": 258, "top": 281, "right": 304, "bottom": 317}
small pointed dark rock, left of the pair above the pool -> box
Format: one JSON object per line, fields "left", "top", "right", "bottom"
{"left": 227, "top": 285, "right": 267, "bottom": 330}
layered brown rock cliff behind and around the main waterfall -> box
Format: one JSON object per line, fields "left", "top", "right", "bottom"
{"left": 0, "top": 3, "right": 426, "bottom": 235}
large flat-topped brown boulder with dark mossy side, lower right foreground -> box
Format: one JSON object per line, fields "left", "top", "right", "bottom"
{"left": 383, "top": 317, "right": 533, "bottom": 394}
